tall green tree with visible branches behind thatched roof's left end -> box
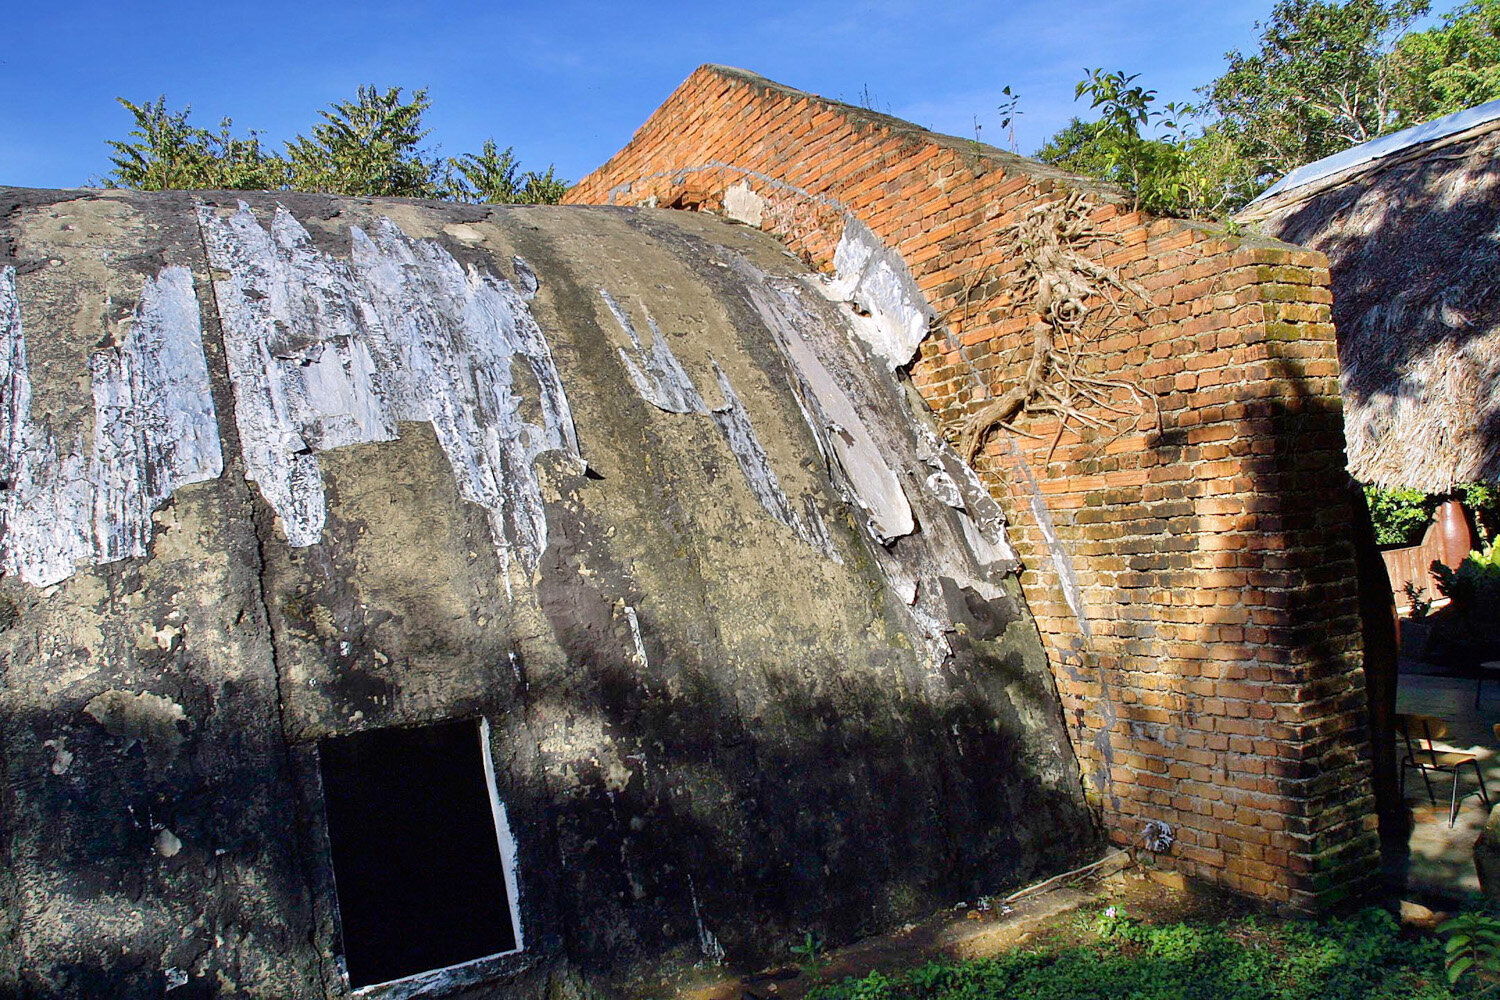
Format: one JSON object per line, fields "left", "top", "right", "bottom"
{"left": 1202, "top": 0, "right": 1428, "bottom": 180}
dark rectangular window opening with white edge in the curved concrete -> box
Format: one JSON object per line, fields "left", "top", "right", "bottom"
{"left": 318, "top": 720, "right": 521, "bottom": 988}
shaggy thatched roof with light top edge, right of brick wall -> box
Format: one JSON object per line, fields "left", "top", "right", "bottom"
{"left": 1239, "top": 102, "right": 1500, "bottom": 493}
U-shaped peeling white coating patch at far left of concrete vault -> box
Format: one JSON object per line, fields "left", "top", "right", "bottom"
{"left": 0, "top": 267, "right": 224, "bottom": 586}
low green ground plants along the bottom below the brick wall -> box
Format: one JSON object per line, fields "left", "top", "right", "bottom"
{"left": 807, "top": 907, "right": 1481, "bottom": 1000}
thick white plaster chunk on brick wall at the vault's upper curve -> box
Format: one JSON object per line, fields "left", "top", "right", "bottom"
{"left": 828, "top": 216, "right": 935, "bottom": 370}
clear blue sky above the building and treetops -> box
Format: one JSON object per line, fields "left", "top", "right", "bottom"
{"left": 0, "top": 0, "right": 1272, "bottom": 187}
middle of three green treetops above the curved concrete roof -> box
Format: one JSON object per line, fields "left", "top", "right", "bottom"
{"left": 287, "top": 85, "right": 441, "bottom": 198}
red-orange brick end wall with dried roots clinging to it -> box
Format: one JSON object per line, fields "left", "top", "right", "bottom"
{"left": 567, "top": 66, "right": 1377, "bottom": 910}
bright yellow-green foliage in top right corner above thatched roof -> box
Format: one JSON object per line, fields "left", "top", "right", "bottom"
{"left": 1389, "top": 0, "right": 1500, "bottom": 126}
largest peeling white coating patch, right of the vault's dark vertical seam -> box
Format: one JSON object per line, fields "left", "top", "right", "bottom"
{"left": 200, "top": 202, "right": 579, "bottom": 570}
